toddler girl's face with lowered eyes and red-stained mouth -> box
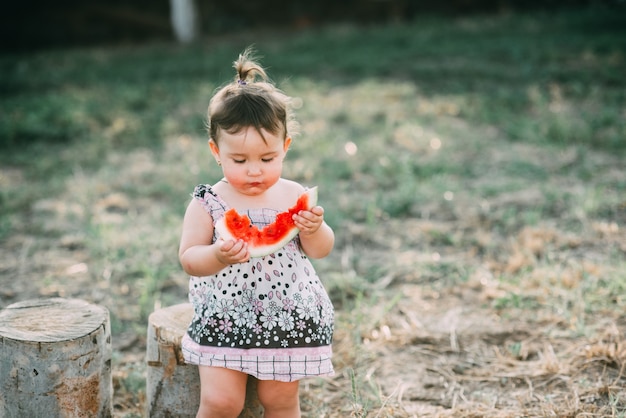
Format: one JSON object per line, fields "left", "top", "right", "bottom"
{"left": 209, "top": 127, "right": 291, "bottom": 196}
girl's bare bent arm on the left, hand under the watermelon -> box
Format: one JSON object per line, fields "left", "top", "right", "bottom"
{"left": 178, "top": 199, "right": 250, "bottom": 276}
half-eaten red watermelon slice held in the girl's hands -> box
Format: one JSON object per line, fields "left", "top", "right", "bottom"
{"left": 215, "top": 187, "right": 317, "bottom": 257}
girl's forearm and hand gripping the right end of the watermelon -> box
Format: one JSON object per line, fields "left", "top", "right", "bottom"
{"left": 293, "top": 206, "right": 335, "bottom": 258}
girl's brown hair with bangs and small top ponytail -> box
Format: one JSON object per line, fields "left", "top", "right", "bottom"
{"left": 207, "top": 47, "right": 297, "bottom": 143}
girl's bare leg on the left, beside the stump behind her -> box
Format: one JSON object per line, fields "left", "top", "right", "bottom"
{"left": 196, "top": 366, "right": 248, "bottom": 418}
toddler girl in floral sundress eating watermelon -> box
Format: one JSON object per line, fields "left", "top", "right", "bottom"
{"left": 179, "top": 49, "right": 335, "bottom": 418}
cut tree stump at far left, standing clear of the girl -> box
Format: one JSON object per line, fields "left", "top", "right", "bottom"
{"left": 0, "top": 298, "right": 113, "bottom": 418}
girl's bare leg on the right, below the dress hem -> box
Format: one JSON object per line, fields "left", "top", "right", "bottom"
{"left": 257, "top": 380, "right": 300, "bottom": 418}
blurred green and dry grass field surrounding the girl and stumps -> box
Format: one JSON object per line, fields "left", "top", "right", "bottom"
{"left": 0, "top": 7, "right": 626, "bottom": 417}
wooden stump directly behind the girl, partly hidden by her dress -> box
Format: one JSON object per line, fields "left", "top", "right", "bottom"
{"left": 146, "top": 303, "right": 263, "bottom": 418}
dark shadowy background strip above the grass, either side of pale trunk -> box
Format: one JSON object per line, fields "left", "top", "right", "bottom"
{"left": 0, "top": 0, "right": 626, "bottom": 53}
